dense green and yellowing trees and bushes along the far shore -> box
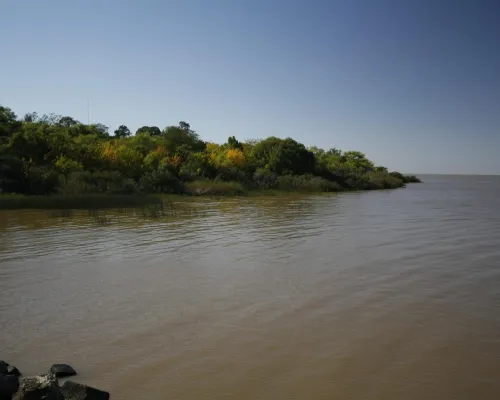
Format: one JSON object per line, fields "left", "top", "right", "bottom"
{"left": 0, "top": 106, "right": 416, "bottom": 196}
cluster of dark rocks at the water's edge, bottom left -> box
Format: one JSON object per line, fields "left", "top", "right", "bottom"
{"left": 0, "top": 360, "right": 110, "bottom": 400}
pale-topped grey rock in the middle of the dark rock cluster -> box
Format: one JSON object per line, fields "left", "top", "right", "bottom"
{"left": 12, "top": 374, "right": 60, "bottom": 400}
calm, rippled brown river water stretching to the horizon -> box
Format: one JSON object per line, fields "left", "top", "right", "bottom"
{"left": 0, "top": 176, "right": 500, "bottom": 399}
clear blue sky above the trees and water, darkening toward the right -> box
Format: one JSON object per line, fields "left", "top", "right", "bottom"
{"left": 0, "top": 0, "right": 500, "bottom": 174}
